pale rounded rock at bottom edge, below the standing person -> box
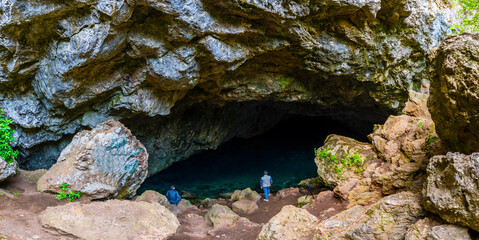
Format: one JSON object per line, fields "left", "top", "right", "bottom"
{"left": 256, "top": 205, "right": 319, "bottom": 240}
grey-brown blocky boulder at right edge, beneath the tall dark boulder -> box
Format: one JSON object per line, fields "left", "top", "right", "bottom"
{"left": 423, "top": 153, "right": 479, "bottom": 231}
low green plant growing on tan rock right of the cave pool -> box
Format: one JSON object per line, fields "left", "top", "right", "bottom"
{"left": 314, "top": 148, "right": 364, "bottom": 179}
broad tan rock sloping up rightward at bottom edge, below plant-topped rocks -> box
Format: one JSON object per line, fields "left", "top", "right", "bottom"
{"left": 316, "top": 192, "right": 425, "bottom": 240}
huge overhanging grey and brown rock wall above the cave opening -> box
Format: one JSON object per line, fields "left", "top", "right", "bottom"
{"left": 0, "top": 0, "right": 450, "bottom": 171}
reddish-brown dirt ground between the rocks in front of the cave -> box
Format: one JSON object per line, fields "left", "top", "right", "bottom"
{"left": 0, "top": 172, "right": 347, "bottom": 240}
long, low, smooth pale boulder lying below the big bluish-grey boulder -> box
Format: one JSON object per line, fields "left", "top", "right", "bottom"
{"left": 39, "top": 200, "right": 180, "bottom": 240}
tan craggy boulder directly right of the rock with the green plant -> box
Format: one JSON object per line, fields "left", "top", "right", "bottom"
{"left": 368, "top": 91, "right": 442, "bottom": 194}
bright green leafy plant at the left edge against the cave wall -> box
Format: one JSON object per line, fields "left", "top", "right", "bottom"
{"left": 0, "top": 109, "right": 18, "bottom": 164}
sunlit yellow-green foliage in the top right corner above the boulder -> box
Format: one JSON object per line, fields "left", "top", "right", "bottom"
{"left": 448, "top": 0, "right": 479, "bottom": 35}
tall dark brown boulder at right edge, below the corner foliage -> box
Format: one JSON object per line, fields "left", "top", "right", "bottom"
{"left": 428, "top": 33, "right": 479, "bottom": 154}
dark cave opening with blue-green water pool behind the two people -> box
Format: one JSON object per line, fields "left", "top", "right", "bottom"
{"left": 138, "top": 115, "right": 373, "bottom": 199}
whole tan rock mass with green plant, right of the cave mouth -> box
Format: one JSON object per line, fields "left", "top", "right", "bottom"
{"left": 315, "top": 91, "right": 444, "bottom": 207}
